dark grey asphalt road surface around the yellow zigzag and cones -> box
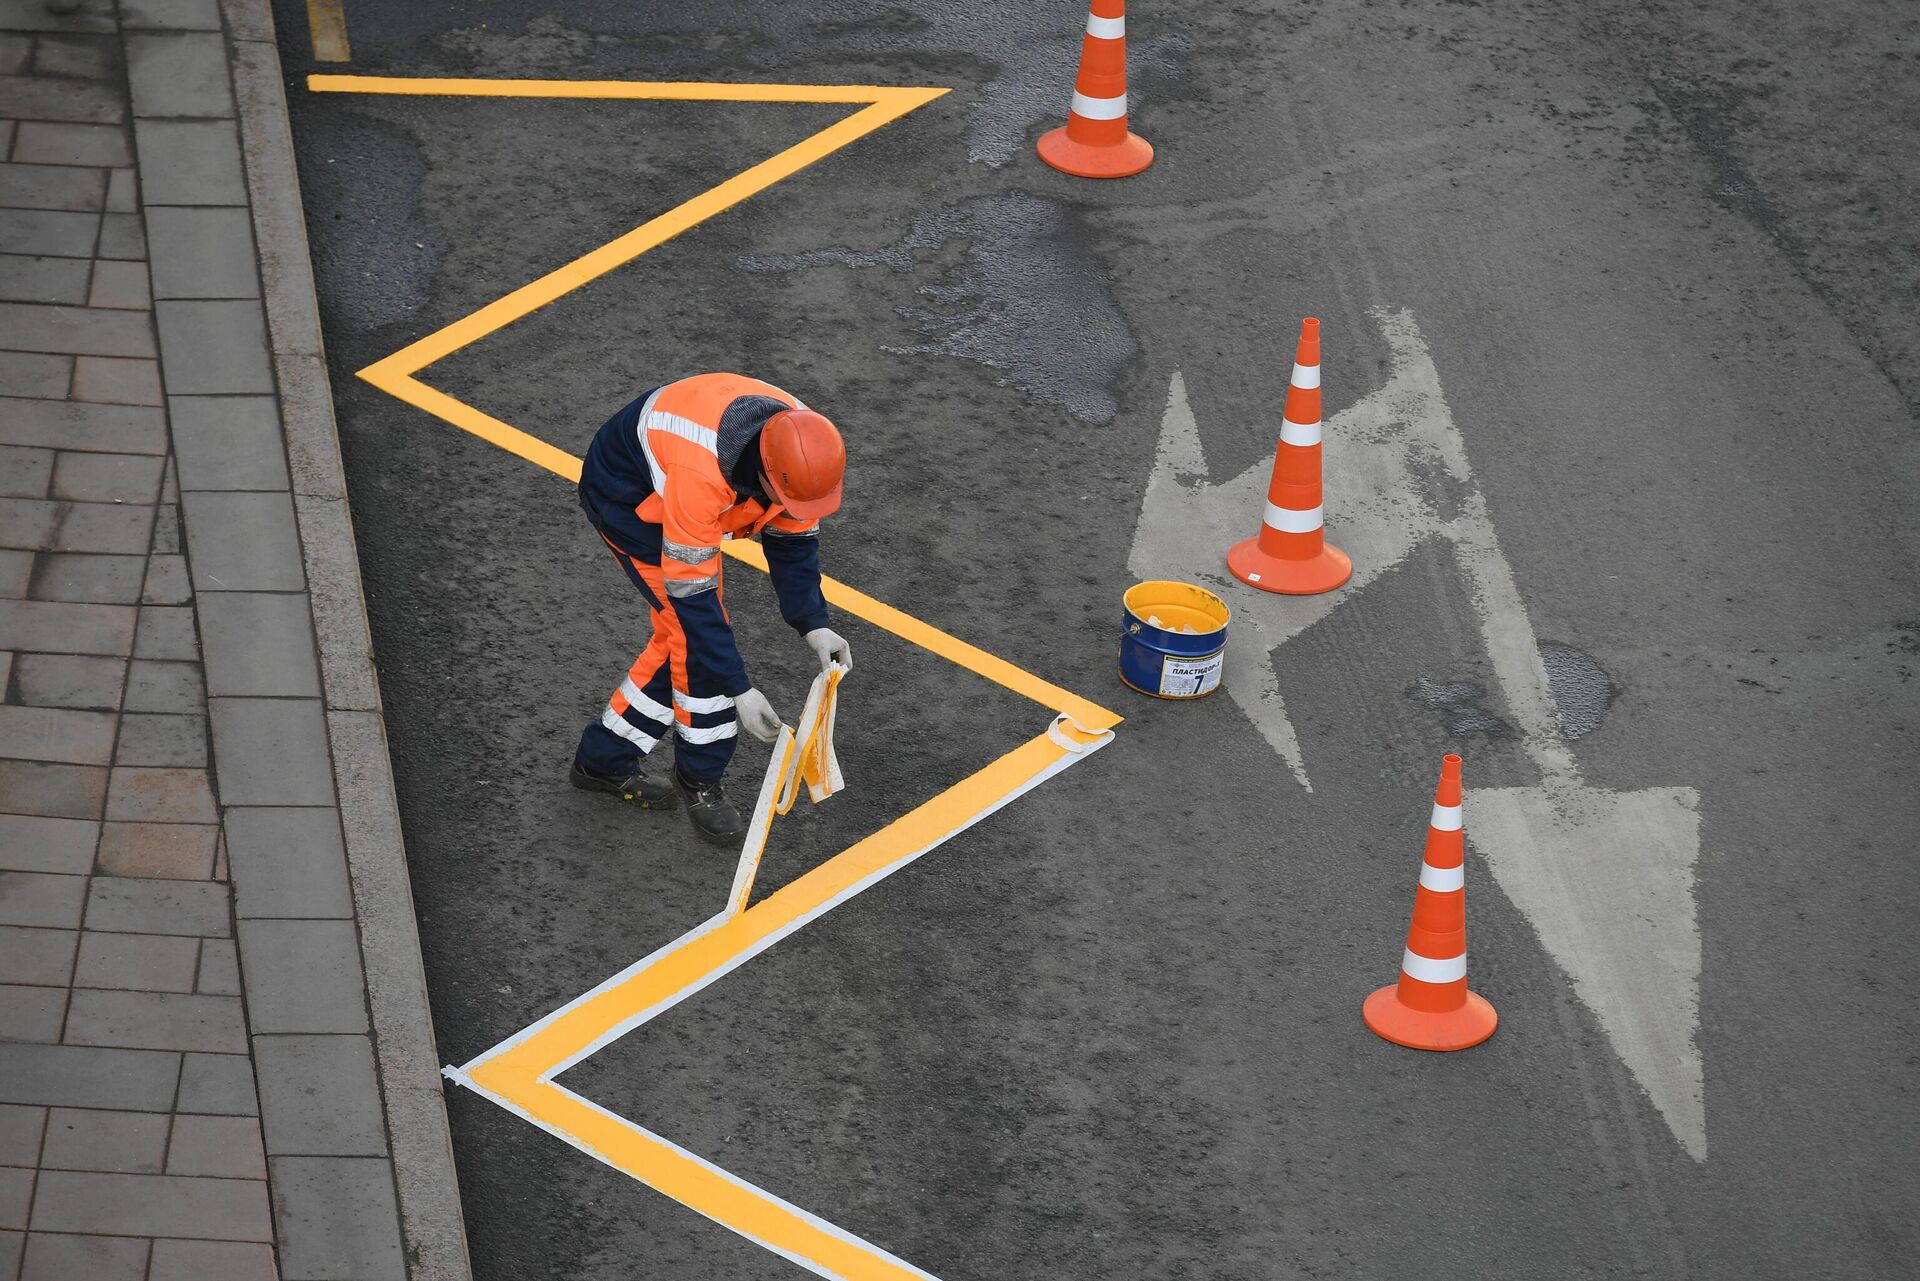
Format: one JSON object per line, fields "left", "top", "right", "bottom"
{"left": 278, "top": 0, "right": 1920, "bottom": 1281}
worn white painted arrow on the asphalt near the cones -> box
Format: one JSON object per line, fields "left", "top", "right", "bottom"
{"left": 1127, "top": 311, "right": 1707, "bottom": 1160}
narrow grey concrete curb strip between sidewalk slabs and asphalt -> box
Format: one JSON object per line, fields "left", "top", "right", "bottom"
{"left": 221, "top": 0, "right": 472, "bottom": 1281}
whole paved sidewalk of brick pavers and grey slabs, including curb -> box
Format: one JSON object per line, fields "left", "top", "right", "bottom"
{"left": 0, "top": 0, "right": 467, "bottom": 1281}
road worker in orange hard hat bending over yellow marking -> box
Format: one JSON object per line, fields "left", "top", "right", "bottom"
{"left": 572, "top": 375, "right": 852, "bottom": 843}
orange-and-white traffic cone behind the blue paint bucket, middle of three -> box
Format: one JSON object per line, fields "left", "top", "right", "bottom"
{"left": 1227, "top": 317, "right": 1354, "bottom": 595}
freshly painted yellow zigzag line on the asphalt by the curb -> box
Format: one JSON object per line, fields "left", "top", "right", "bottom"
{"left": 307, "top": 75, "right": 1121, "bottom": 1281}
